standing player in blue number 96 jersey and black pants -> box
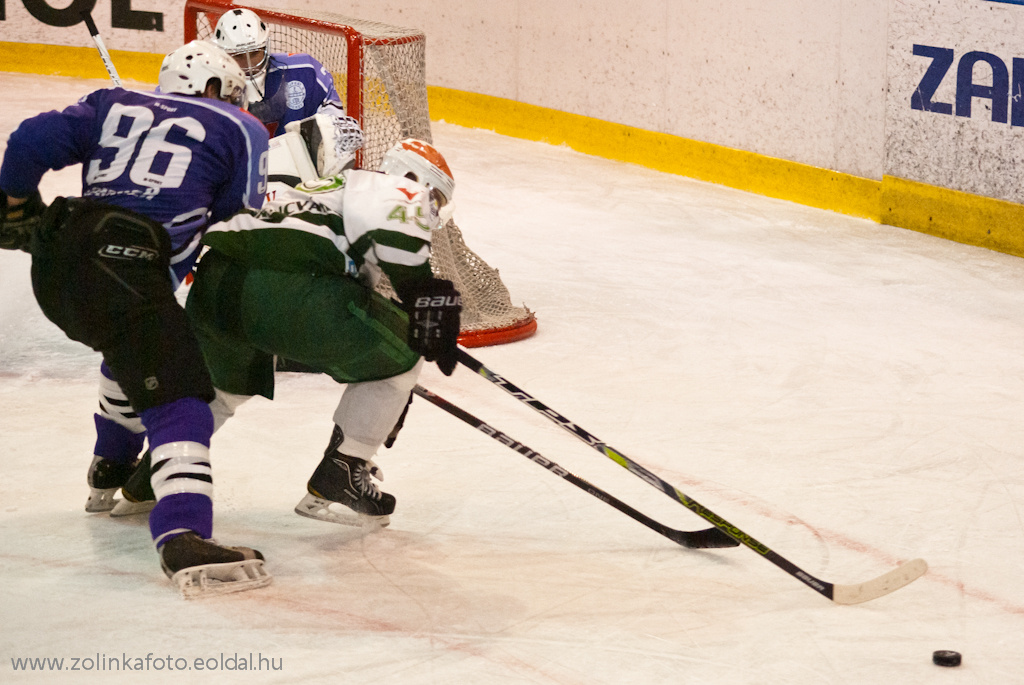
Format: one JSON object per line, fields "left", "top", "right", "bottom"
{"left": 0, "top": 41, "right": 270, "bottom": 596}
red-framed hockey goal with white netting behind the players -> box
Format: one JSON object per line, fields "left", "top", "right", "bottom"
{"left": 184, "top": 0, "right": 537, "bottom": 347}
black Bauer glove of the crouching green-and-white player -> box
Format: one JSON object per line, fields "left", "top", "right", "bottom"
{"left": 397, "top": 279, "right": 462, "bottom": 376}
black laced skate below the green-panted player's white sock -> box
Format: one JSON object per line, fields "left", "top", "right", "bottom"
{"left": 295, "top": 426, "right": 394, "bottom": 527}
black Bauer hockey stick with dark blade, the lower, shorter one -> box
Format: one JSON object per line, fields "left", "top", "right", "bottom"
{"left": 413, "top": 385, "right": 739, "bottom": 550}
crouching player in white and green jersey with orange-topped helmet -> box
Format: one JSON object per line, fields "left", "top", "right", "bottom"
{"left": 180, "top": 132, "right": 462, "bottom": 525}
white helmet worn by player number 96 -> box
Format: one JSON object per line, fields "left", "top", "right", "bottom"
{"left": 158, "top": 40, "right": 246, "bottom": 108}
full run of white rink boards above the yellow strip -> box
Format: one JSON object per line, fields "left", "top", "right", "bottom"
{"left": 3, "top": 0, "right": 1024, "bottom": 203}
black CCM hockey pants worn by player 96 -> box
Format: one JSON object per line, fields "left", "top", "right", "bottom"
{"left": 32, "top": 198, "right": 214, "bottom": 412}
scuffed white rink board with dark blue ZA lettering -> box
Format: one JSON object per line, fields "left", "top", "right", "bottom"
{"left": 886, "top": 0, "right": 1024, "bottom": 203}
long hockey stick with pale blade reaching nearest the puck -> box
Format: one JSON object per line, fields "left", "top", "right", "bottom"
{"left": 459, "top": 347, "right": 928, "bottom": 604}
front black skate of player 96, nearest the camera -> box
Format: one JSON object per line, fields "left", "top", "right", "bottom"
{"left": 160, "top": 530, "right": 272, "bottom": 599}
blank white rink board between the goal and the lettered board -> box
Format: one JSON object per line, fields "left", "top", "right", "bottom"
{"left": 276, "top": 0, "right": 886, "bottom": 180}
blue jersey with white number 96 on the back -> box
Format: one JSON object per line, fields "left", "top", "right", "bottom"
{"left": 0, "top": 88, "right": 267, "bottom": 276}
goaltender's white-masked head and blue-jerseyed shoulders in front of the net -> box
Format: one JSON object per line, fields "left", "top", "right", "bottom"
{"left": 213, "top": 8, "right": 344, "bottom": 136}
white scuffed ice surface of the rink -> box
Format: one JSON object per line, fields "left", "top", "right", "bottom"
{"left": 0, "top": 75, "right": 1024, "bottom": 685}
